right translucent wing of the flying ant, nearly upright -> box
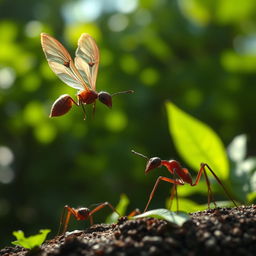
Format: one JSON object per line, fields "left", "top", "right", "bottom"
{"left": 75, "top": 33, "right": 100, "bottom": 90}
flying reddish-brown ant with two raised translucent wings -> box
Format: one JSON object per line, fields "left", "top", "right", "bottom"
{"left": 41, "top": 33, "right": 133, "bottom": 119}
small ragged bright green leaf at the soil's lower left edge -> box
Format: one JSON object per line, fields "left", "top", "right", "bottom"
{"left": 12, "top": 229, "right": 51, "bottom": 249}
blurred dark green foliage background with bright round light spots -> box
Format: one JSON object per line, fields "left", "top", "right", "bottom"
{"left": 0, "top": 0, "right": 256, "bottom": 247}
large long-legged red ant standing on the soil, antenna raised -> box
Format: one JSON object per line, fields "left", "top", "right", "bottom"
{"left": 132, "top": 150, "right": 237, "bottom": 212}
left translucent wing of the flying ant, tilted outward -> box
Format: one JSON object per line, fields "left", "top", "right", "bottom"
{"left": 41, "top": 33, "right": 89, "bottom": 90}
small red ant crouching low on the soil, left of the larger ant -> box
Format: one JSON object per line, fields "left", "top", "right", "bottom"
{"left": 58, "top": 202, "right": 121, "bottom": 234}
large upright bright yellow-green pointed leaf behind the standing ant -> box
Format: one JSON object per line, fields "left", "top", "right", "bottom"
{"left": 166, "top": 102, "right": 229, "bottom": 180}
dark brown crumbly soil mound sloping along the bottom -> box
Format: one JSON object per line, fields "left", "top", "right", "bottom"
{"left": 0, "top": 205, "right": 256, "bottom": 256}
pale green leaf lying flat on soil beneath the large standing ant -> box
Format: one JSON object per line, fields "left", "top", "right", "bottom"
{"left": 133, "top": 209, "right": 189, "bottom": 226}
